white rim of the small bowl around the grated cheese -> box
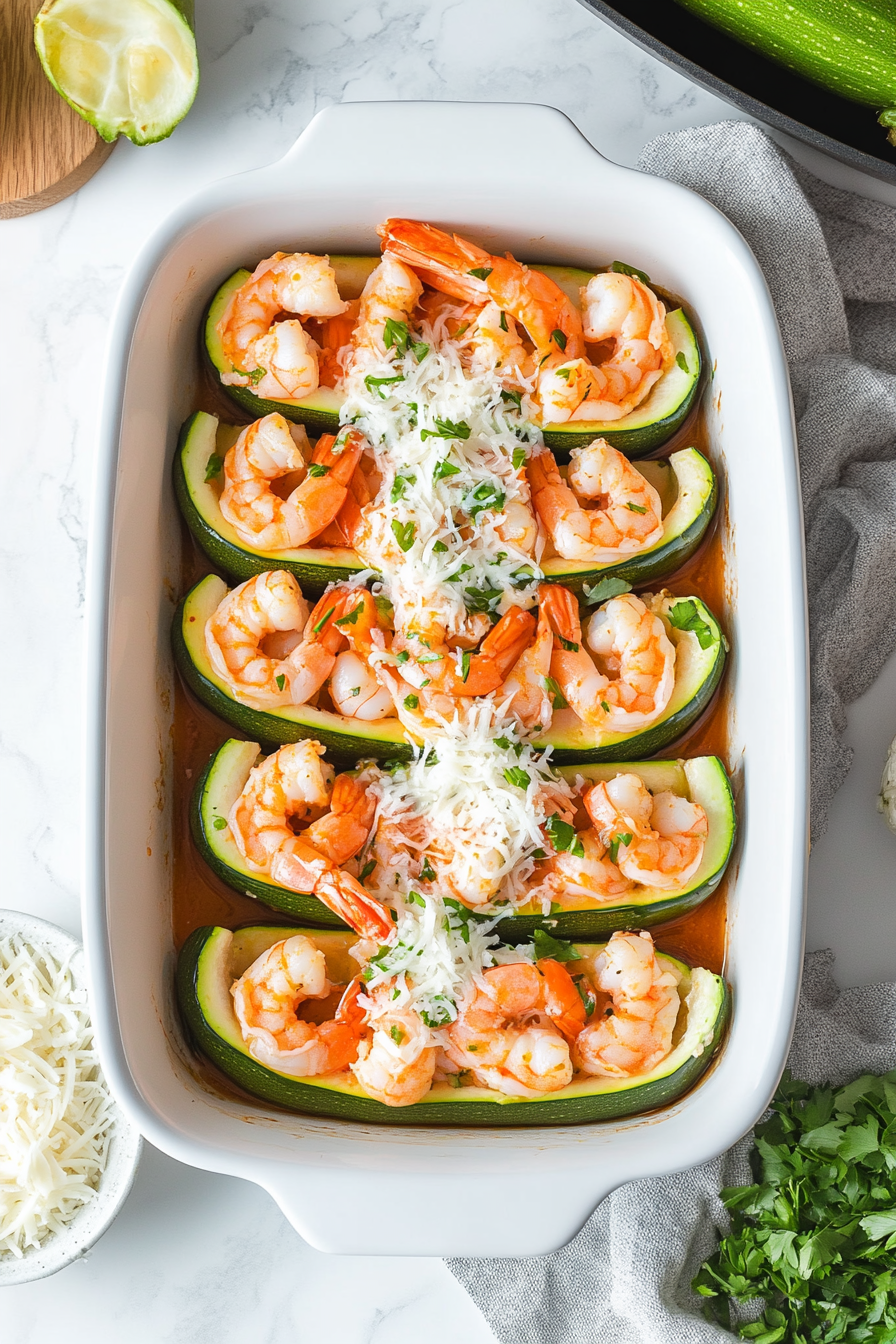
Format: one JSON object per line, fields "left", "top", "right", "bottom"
{"left": 0, "top": 910, "right": 142, "bottom": 1288}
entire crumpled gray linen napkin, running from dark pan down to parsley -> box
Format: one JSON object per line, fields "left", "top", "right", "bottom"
{"left": 447, "top": 122, "right": 896, "bottom": 1344}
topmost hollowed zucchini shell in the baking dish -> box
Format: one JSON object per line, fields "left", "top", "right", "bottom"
{"left": 204, "top": 257, "right": 703, "bottom": 457}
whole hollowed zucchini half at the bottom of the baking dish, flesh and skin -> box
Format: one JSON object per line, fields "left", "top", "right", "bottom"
{"left": 177, "top": 925, "right": 731, "bottom": 1126}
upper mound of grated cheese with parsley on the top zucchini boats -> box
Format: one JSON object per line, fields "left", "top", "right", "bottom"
{"left": 343, "top": 316, "right": 543, "bottom": 636}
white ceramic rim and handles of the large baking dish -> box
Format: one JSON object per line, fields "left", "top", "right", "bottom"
{"left": 83, "top": 103, "right": 809, "bottom": 1254}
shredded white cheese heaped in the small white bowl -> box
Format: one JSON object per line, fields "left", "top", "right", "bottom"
{"left": 0, "top": 935, "right": 114, "bottom": 1258}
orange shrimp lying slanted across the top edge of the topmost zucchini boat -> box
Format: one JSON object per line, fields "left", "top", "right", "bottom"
{"left": 377, "top": 219, "right": 584, "bottom": 374}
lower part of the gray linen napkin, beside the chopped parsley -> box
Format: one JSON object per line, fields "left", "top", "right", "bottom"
{"left": 447, "top": 952, "right": 896, "bottom": 1344}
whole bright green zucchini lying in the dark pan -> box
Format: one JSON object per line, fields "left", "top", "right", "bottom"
{"left": 678, "top": 0, "right": 896, "bottom": 144}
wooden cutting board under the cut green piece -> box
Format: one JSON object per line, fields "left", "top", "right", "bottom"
{"left": 0, "top": 0, "right": 114, "bottom": 219}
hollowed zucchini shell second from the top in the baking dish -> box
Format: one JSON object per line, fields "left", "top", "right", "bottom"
{"left": 173, "top": 411, "right": 717, "bottom": 593}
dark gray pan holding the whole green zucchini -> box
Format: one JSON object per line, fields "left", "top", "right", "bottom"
{"left": 580, "top": 0, "right": 896, "bottom": 183}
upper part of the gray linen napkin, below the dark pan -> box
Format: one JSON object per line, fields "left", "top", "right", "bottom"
{"left": 638, "top": 121, "right": 896, "bottom": 840}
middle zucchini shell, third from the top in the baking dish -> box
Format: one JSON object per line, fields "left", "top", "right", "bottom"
{"left": 172, "top": 574, "right": 725, "bottom": 765}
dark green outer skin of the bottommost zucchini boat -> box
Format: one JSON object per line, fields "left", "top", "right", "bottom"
{"left": 176, "top": 926, "right": 731, "bottom": 1128}
